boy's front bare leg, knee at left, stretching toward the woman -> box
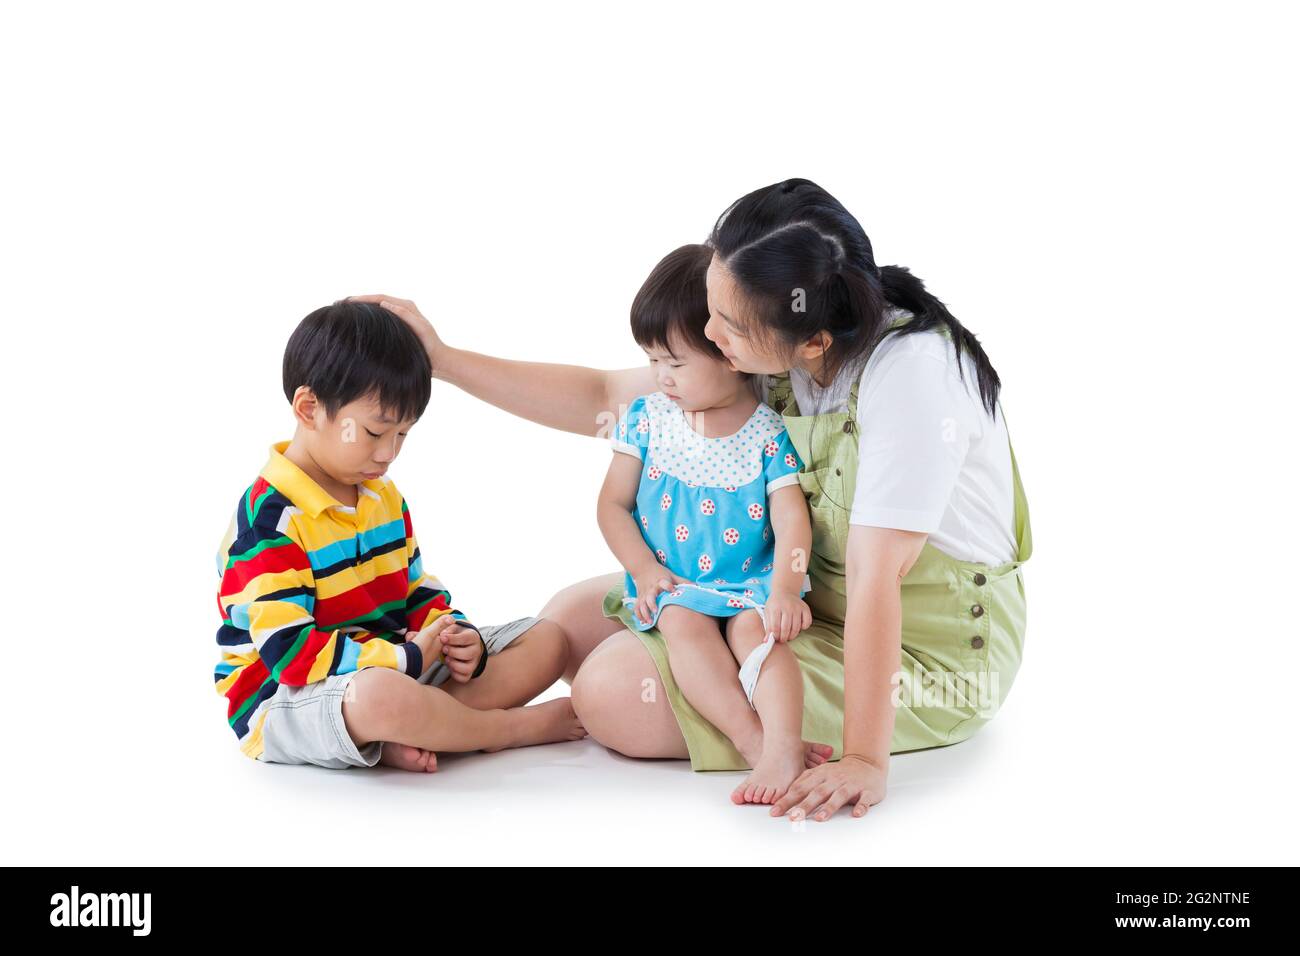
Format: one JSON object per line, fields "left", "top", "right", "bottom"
{"left": 343, "top": 667, "right": 585, "bottom": 752}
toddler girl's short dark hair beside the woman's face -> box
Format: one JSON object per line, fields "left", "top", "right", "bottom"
{"left": 632, "top": 243, "right": 723, "bottom": 362}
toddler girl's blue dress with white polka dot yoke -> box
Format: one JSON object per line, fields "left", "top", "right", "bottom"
{"left": 612, "top": 392, "right": 810, "bottom": 631}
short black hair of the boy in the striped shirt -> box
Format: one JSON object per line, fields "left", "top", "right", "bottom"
{"left": 283, "top": 299, "right": 433, "bottom": 421}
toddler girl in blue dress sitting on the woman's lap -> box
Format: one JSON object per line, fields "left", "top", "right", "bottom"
{"left": 598, "top": 246, "right": 813, "bottom": 804}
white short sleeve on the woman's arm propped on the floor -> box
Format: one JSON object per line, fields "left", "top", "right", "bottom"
{"left": 849, "top": 352, "right": 983, "bottom": 533}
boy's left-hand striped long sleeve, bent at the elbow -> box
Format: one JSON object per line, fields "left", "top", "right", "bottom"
{"left": 218, "top": 525, "right": 424, "bottom": 687}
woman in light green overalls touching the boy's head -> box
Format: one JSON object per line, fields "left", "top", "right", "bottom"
{"left": 351, "top": 179, "right": 1032, "bottom": 821}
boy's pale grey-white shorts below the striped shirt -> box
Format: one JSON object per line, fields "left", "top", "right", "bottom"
{"left": 257, "top": 617, "right": 541, "bottom": 770}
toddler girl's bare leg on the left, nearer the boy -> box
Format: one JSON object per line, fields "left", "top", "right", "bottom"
{"left": 658, "top": 605, "right": 764, "bottom": 766}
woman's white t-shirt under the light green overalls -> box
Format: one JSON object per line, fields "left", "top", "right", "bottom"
{"left": 764, "top": 310, "right": 1017, "bottom": 564}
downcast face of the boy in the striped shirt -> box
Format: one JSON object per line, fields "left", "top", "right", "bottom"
{"left": 308, "top": 398, "right": 415, "bottom": 485}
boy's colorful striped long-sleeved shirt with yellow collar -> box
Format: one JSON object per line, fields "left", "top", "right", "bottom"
{"left": 215, "top": 441, "right": 486, "bottom": 758}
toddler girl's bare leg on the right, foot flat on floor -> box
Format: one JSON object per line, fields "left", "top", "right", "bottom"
{"left": 728, "top": 610, "right": 805, "bottom": 804}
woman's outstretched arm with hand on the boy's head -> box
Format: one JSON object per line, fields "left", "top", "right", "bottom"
{"left": 351, "top": 295, "right": 657, "bottom": 436}
